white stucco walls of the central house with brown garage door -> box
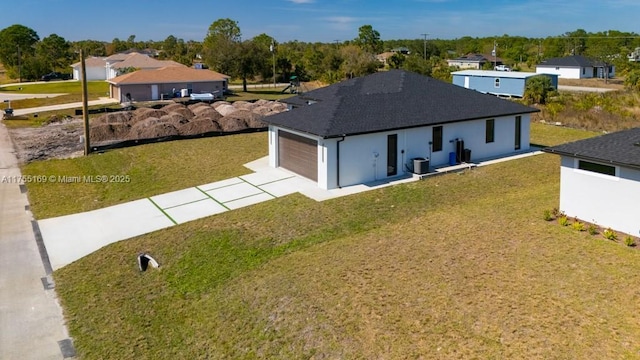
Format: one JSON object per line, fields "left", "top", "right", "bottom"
{"left": 269, "top": 114, "right": 530, "bottom": 189}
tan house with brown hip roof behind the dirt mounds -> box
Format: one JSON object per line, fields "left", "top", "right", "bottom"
{"left": 107, "top": 66, "right": 229, "bottom": 102}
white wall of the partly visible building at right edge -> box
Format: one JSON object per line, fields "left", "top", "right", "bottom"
{"left": 560, "top": 156, "right": 640, "bottom": 236}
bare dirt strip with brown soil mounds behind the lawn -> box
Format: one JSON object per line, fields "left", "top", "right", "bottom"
{"left": 9, "top": 100, "right": 287, "bottom": 163}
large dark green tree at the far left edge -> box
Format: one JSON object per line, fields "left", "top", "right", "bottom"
{"left": 0, "top": 24, "right": 40, "bottom": 78}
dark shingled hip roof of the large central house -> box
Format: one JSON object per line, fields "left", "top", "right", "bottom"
{"left": 264, "top": 70, "right": 539, "bottom": 138}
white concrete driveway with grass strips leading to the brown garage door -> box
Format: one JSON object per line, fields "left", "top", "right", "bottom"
{"left": 38, "top": 157, "right": 416, "bottom": 270}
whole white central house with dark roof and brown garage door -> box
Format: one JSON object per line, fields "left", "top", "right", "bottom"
{"left": 263, "top": 70, "right": 538, "bottom": 189}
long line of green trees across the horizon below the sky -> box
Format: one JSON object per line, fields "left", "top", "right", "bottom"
{"left": 0, "top": 18, "right": 640, "bottom": 83}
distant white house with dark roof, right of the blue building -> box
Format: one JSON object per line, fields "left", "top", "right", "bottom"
{"left": 536, "top": 55, "right": 615, "bottom": 79}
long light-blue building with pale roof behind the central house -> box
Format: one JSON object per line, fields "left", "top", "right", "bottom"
{"left": 451, "top": 70, "right": 558, "bottom": 97}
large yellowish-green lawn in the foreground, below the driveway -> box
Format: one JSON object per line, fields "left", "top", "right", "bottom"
{"left": 54, "top": 128, "right": 640, "bottom": 359}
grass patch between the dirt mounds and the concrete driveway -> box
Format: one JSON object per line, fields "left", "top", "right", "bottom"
{"left": 22, "top": 132, "right": 267, "bottom": 219}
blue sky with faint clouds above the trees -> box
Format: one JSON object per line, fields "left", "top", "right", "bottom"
{"left": 0, "top": 0, "right": 640, "bottom": 42}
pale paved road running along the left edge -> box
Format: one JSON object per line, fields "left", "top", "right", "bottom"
{"left": 0, "top": 122, "right": 73, "bottom": 360}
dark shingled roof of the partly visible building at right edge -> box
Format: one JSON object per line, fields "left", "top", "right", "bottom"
{"left": 543, "top": 128, "right": 640, "bottom": 169}
